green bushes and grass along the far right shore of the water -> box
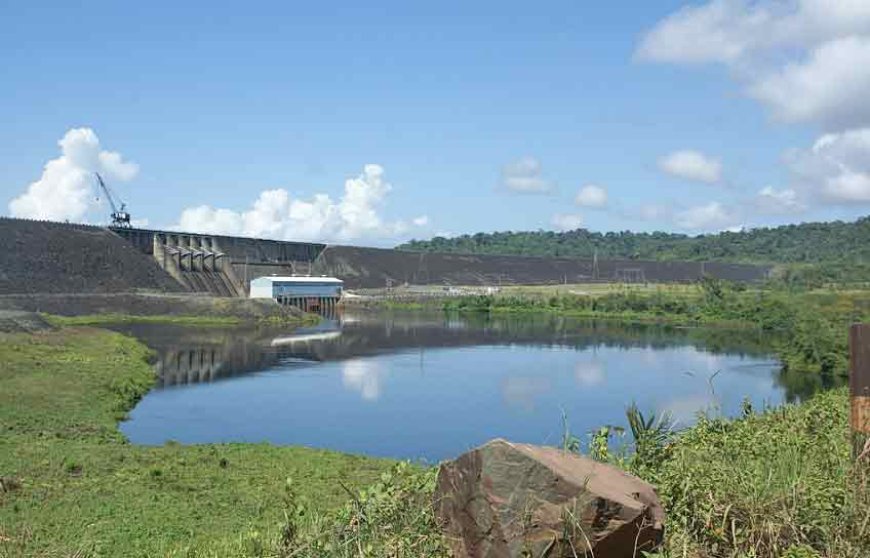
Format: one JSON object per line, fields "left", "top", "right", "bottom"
{"left": 441, "top": 279, "right": 870, "bottom": 375}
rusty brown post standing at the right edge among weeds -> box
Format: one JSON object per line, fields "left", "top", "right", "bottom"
{"left": 849, "top": 324, "right": 870, "bottom": 459}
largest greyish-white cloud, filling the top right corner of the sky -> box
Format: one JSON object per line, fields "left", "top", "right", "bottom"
{"left": 636, "top": 0, "right": 870, "bottom": 130}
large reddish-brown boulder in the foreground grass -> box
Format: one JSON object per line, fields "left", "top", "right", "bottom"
{"left": 435, "top": 439, "right": 664, "bottom": 558}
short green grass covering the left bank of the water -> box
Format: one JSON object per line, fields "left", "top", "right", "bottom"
{"left": 0, "top": 328, "right": 394, "bottom": 556}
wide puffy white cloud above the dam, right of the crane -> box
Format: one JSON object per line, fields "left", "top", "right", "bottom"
{"left": 174, "top": 164, "right": 428, "bottom": 245}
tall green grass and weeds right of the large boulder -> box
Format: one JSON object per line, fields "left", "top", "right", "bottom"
{"left": 640, "top": 389, "right": 870, "bottom": 558}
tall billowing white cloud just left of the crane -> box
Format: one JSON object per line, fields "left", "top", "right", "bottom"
{"left": 9, "top": 128, "right": 139, "bottom": 221}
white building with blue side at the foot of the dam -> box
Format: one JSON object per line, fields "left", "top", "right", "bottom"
{"left": 250, "top": 276, "right": 344, "bottom": 312}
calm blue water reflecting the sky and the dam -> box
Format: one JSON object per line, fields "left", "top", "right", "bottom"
{"left": 115, "top": 314, "right": 817, "bottom": 462}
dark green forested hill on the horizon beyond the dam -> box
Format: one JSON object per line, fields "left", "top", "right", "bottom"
{"left": 399, "top": 217, "right": 870, "bottom": 264}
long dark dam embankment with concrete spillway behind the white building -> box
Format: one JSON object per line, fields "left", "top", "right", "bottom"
{"left": 0, "top": 218, "right": 770, "bottom": 297}
